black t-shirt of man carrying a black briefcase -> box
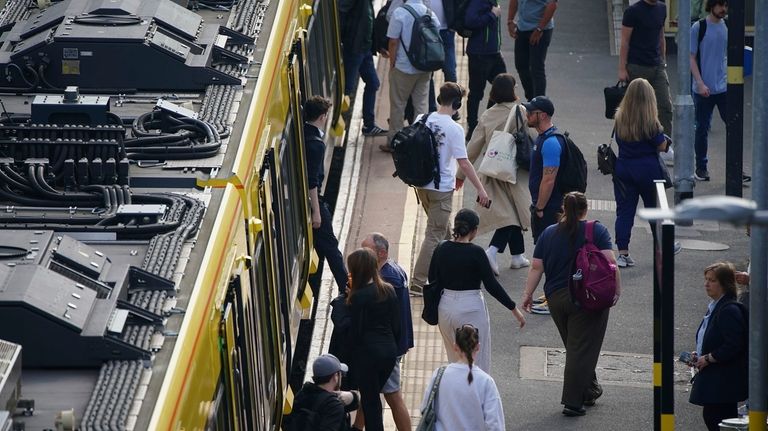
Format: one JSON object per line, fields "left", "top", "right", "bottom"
{"left": 621, "top": 0, "right": 667, "bottom": 66}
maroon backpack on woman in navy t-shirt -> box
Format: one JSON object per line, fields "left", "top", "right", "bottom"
{"left": 568, "top": 220, "right": 617, "bottom": 311}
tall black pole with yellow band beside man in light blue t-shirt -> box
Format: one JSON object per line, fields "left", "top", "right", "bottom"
{"left": 725, "top": 0, "right": 744, "bottom": 197}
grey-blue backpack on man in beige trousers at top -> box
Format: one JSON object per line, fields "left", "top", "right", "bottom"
{"left": 400, "top": 4, "right": 445, "bottom": 72}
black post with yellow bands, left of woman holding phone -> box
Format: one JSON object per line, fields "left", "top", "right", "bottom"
{"left": 653, "top": 181, "right": 675, "bottom": 431}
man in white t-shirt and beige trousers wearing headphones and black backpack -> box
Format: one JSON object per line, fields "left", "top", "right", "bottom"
{"left": 411, "top": 82, "right": 490, "bottom": 294}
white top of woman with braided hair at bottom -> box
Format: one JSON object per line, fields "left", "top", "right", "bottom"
{"left": 421, "top": 363, "right": 506, "bottom": 431}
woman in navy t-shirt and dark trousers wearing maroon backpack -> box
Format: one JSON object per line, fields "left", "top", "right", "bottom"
{"left": 523, "top": 192, "right": 621, "bottom": 416}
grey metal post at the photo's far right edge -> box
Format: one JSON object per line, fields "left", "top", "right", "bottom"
{"left": 752, "top": 0, "right": 768, "bottom": 431}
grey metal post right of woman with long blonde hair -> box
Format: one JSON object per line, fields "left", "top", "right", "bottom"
{"left": 666, "top": 1, "right": 696, "bottom": 203}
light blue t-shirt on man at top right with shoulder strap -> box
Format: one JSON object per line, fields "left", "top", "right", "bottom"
{"left": 691, "top": 19, "right": 728, "bottom": 94}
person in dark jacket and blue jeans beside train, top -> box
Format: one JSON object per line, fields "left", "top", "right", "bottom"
{"left": 339, "top": 0, "right": 387, "bottom": 136}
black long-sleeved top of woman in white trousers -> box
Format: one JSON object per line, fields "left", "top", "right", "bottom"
{"left": 429, "top": 241, "right": 515, "bottom": 310}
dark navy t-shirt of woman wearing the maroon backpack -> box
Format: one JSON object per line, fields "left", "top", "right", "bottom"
{"left": 533, "top": 221, "right": 613, "bottom": 296}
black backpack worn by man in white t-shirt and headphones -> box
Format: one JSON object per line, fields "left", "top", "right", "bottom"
{"left": 389, "top": 114, "right": 440, "bottom": 189}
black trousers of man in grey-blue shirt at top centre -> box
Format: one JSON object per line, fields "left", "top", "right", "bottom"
{"left": 515, "top": 29, "right": 553, "bottom": 100}
